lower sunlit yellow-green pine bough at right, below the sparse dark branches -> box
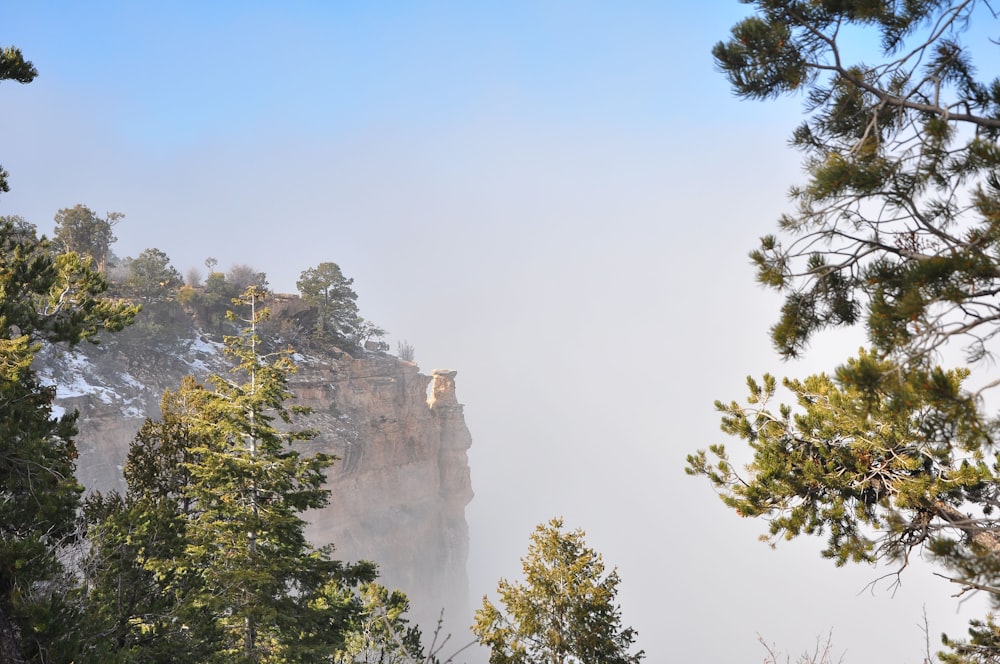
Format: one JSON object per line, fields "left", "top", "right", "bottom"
{"left": 688, "top": 352, "right": 1000, "bottom": 564}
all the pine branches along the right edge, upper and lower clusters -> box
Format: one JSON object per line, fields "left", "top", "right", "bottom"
{"left": 688, "top": 0, "right": 1000, "bottom": 662}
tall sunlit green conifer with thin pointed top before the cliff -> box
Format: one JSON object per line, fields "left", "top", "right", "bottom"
{"left": 185, "top": 289, "right": 348, "bottom": 661}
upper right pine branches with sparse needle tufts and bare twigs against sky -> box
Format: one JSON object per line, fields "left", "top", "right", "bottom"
{"left": 713, "top": 0, "right": 1000, "bottom": 359}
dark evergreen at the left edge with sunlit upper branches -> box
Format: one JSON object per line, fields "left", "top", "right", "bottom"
{"left": 0, "top": 219, "right": 137, "bottom": 658}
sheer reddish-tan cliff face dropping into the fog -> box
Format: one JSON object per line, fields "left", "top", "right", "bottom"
{"left": 295, "top": 354, "right": 472, "bottom": 625}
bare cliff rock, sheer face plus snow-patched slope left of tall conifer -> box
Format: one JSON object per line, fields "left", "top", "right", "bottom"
{"left": 39, "top": 324, "right": 473, "bottom": 629}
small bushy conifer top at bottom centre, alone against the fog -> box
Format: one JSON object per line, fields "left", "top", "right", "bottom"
{"left": 472, "top": 519, "right": 644, "bottom": 664}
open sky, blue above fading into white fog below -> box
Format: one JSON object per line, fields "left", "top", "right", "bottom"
{"left": 0, "top": 0, "right": 981, "bottom": 663}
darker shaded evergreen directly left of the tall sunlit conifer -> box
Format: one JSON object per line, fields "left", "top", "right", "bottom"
{"left": 81, "top": 386, "right": 222, "bottom": 664}
